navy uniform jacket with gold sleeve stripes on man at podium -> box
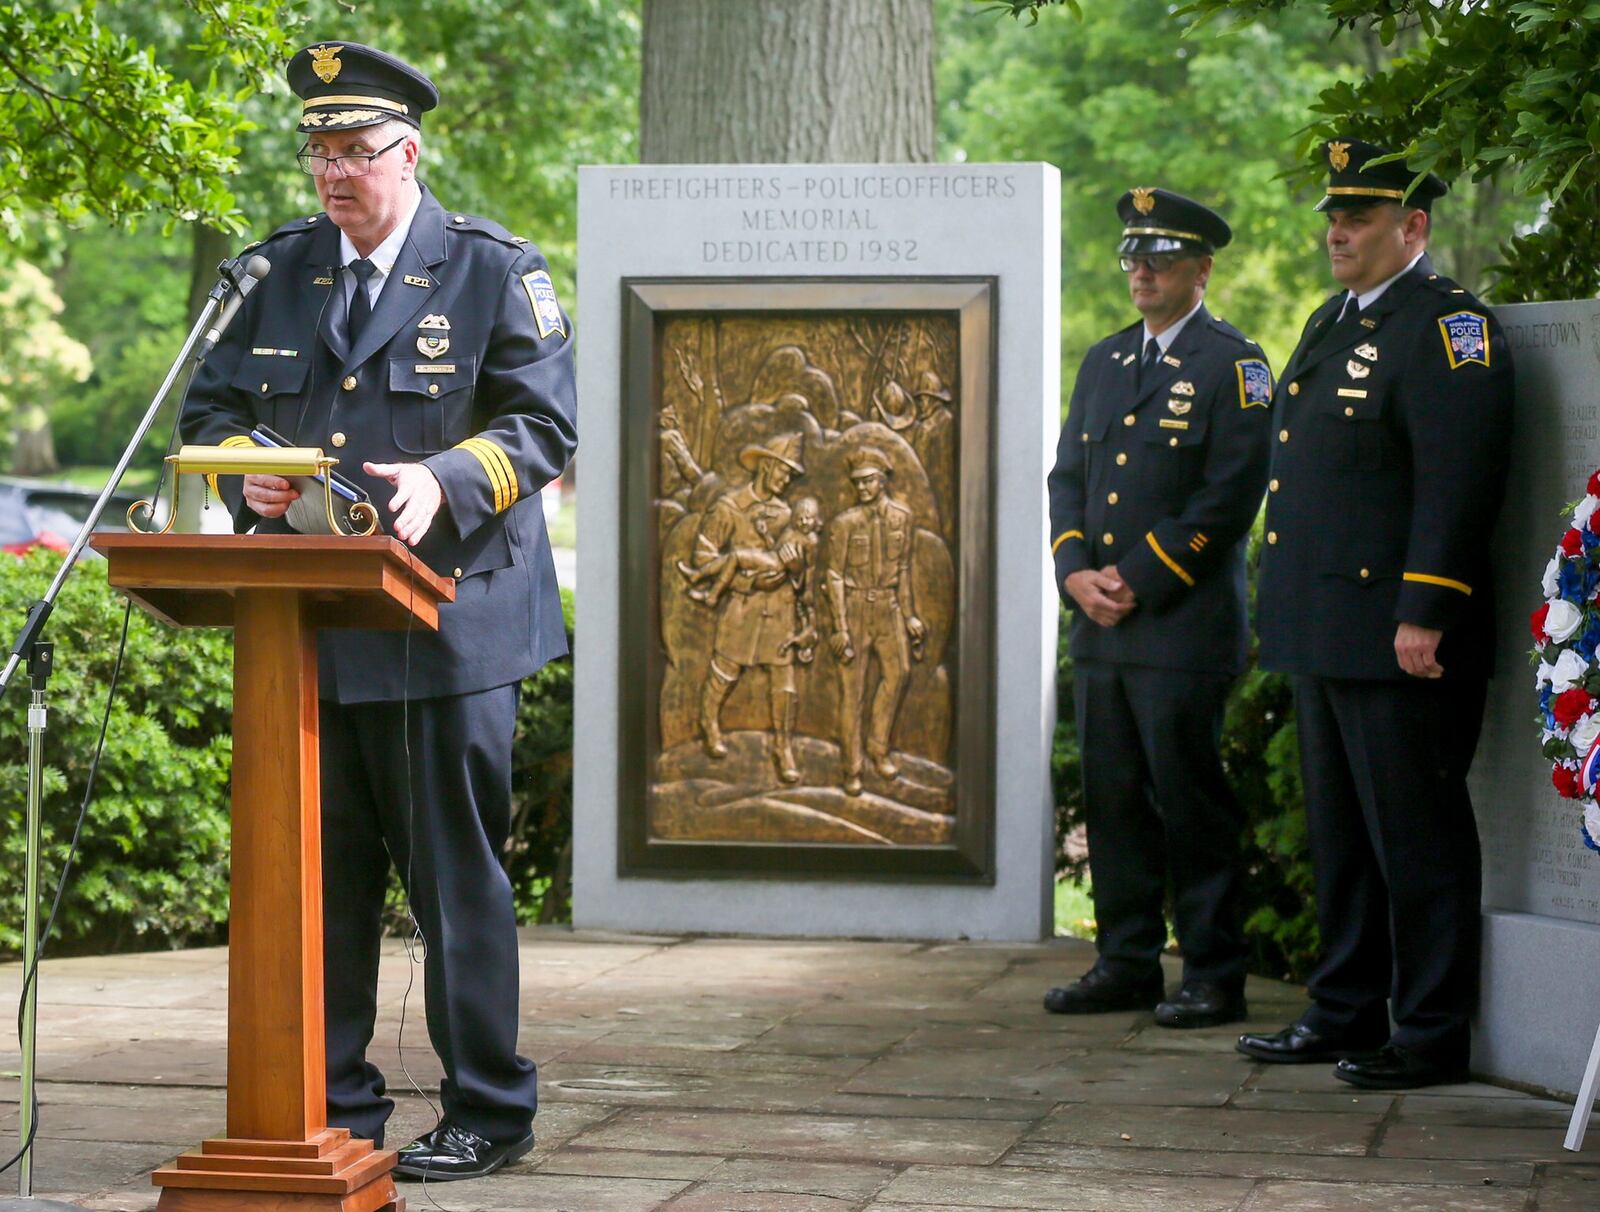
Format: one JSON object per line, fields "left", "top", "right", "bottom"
{"left": 182, "top": 187, "right": 578, "bottom": 704}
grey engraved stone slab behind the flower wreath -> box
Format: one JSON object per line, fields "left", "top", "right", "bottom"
{"left": 1472, "top": 299, "right": 1600, "bottom": 1092}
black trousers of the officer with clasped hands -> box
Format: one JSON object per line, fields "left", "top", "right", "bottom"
{"left": 1072, "top": 660, "right": 1245, "bottom": 988}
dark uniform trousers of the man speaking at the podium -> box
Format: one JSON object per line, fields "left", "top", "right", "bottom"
{"left": 318, "top": 684, "right": 538, "bottom": 1143}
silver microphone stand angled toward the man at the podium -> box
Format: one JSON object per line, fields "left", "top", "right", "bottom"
{"left": 0, "top": 278, "right": 227, "bottom": 1207}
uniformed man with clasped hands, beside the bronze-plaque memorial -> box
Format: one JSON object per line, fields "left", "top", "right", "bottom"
{"left": 1045, "top": 189, "right": 1272, "bottom": 1027}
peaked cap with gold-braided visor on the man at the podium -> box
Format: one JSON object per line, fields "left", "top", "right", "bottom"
{"left": 286, "top": 42, "right": 438, "bottom": 134}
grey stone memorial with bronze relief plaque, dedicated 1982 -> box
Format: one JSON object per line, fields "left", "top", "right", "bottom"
{"left": 573, "top": 165, "right": 1059, "bottom": 939}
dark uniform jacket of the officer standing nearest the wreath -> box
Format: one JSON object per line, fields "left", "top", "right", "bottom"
{"left": 1258, "top": 256, "right": 1512, "bottom": 680}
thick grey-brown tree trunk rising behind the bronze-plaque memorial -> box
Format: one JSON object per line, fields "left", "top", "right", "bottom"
{"left": 640, "top": 0, "right": 936, "bottom": 163}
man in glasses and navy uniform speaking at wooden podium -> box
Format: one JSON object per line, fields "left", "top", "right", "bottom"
{"left": 182, "top": 42, "right": 576, "bottom": 1180}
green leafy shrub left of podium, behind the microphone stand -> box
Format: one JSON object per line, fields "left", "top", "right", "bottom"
{"left": 0, "top": 548, "right": 234, "bottom": 953}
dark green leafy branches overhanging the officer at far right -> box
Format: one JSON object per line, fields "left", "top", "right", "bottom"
{"left": 1179, "top": 0, "right": 1600, "bottom": 302}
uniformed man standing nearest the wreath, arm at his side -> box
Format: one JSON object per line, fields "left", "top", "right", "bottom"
{"left": 1238, "top": 139, "right": 1512, "bottom": 1089}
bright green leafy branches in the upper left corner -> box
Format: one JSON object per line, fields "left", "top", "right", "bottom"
{"left": 0, "top": 0, "right": 299, "bottom": 240}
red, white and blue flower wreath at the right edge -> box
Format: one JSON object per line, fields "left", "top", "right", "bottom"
{"left": 1530, "top": 472, "right": 1600, "bottom": 851}
